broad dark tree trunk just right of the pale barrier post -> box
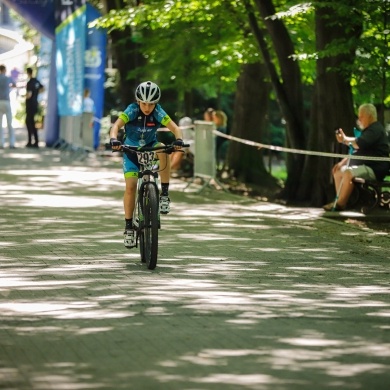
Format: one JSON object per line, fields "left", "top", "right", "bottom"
{"left": 228, "top": 63, "right": 275, "bottom": 184}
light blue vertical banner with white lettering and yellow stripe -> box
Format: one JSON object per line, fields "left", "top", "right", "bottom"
{"left": 55, "top": 0, "right": 86, "bottom": 116}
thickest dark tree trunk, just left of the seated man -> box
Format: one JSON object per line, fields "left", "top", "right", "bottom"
{"left": 297, "top": 1, "right": 362, "bottom": 206}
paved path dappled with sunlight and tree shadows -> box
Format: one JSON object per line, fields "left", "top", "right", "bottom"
{"left": 0, "top": 132, "right": 390, "bottom": 390}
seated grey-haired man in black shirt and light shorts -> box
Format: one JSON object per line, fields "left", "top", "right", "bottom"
{"left": 323, "top": 104, "right": 390, "bottom": 211}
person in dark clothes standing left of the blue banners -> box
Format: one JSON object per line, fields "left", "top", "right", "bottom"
{"left": 26, "top": 68, "right": 45, "bottom": 148}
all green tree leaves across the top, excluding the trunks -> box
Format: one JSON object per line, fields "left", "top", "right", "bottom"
{"left": 94, "top": 0, "right": 390, "bottom": 119}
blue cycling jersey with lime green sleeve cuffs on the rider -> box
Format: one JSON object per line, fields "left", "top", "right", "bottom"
{"left": 119, "top": 103, "right": 171, "bottom": 146}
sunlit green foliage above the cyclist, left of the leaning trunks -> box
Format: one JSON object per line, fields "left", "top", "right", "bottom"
{"left": 92, "top": 0, "right": 259, "bottom": 96}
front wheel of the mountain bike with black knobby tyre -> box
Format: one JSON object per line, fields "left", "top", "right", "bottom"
{"left": 142, "top": 184, "right": 159, "bottom": 269}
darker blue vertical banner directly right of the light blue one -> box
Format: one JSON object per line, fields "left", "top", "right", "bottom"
{"left": 84, "top": 4, "right": 107, "bottom": 149}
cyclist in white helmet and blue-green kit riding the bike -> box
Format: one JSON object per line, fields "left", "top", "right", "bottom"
{"left": 110, "top": 81, "right": 183, "bottom": 248}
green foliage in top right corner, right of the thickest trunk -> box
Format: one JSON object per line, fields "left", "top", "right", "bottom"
{"left": 315, "top": 0, "right": 390, "bottom": 105}
